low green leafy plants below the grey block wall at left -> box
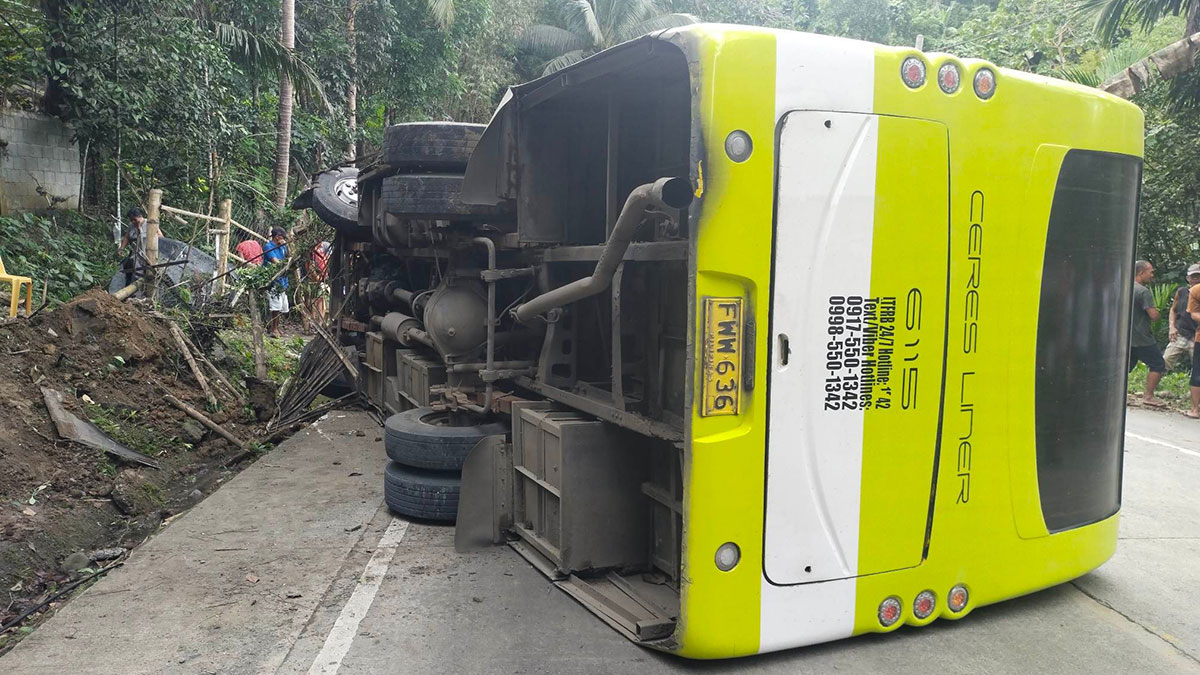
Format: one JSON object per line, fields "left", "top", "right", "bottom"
{"left": 0, "top": 211, "right": 119, "bottom": 300}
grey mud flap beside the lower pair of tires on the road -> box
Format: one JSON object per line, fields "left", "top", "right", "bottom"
{"left": 454, "top": 434, "right": 512, "bottom": 552}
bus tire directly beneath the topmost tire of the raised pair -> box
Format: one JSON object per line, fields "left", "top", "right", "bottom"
{"left": 380, "top": 173, "right": 511, "bottom": 221}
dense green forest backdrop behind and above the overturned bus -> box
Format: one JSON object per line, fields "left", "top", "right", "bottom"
{"left": 0, "top": 0, "right": 1200, "bottom": 279}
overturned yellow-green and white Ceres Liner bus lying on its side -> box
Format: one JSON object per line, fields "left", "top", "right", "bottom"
{"left": 309, "top": 25, "right": 1142, "bottom": 658}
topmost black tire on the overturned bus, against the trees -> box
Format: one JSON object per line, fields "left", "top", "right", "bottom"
{"left": 382, "top": 121, "right": 486, "bottom": 173}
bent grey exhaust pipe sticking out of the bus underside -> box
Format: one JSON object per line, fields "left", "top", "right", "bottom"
{"left": 514, "top": 178, "right": 691, "bottom": 321}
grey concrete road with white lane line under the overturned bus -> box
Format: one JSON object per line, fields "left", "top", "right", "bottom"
{"left": 7, "top": 401, "right": 1200, "bottom": 675}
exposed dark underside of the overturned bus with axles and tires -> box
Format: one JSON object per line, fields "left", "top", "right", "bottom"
{"left": 322, "top": 42, "right": 694, "bottom": 641}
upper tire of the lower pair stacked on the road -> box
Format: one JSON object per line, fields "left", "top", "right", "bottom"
{"left": 384, "top": 408, "right": 508, "bottom": 471}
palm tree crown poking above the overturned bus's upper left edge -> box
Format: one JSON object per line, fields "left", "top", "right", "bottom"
{"left": 521, "top": 0, "right": 700, "bottom": 74}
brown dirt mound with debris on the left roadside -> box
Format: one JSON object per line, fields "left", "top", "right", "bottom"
{"left": 0, "top": 289, "right": 285, "bottom": 653}
